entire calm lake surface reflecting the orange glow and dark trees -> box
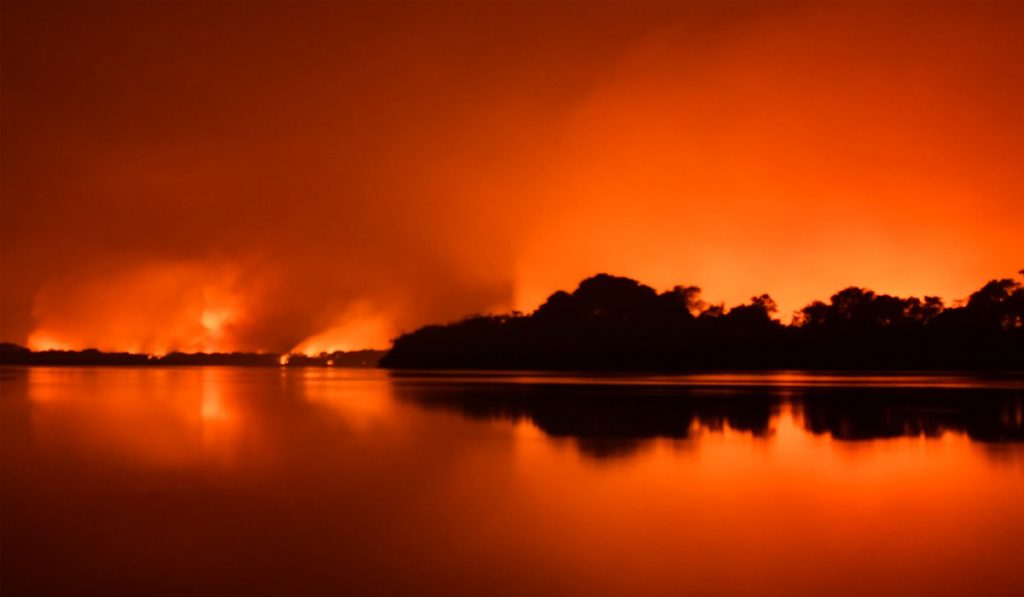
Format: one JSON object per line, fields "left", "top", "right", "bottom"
{"left": 0, "top": 368, "right": 1024, "bottom": 596}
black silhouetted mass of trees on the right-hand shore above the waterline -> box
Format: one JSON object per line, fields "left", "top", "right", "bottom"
{"left": 381, "top": 273, "right": 1024, "bottom": 371}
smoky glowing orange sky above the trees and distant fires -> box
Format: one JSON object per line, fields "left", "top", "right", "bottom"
{"left": 0, "top": 2, "right": 1024, "bottom": 352}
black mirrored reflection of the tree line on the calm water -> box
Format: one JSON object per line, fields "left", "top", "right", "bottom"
{"left": 394, "top": 377, "right": 1024, "bottom": 458}
